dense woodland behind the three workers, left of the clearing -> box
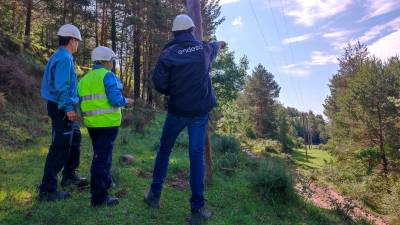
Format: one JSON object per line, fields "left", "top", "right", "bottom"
{"left": 0, "top": 0, "right": 327, "bottom": 151}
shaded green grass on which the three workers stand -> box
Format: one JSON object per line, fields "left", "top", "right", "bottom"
{"left": 0, "top": 115, "right": 356, "bottom": 225}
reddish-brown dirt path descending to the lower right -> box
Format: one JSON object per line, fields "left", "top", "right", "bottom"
{"left": 243, "top": 149, "right": 390, "bottom": 225}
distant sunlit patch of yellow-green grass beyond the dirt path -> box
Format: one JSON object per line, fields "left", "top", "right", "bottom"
{"left": 293, "top": 148, "right": 333, "bottom": 170}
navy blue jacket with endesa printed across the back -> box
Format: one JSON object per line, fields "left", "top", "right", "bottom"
{"left": 152, "top": 32, "right": 220, "bottom": 117}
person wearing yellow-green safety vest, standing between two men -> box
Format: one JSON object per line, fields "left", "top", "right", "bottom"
{"left": 78, "top": 46, "right": 133, "bottom": 206}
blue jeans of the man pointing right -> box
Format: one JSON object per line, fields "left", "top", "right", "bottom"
{"left": 151, "top": 113, "right": 208, "bottom": 211}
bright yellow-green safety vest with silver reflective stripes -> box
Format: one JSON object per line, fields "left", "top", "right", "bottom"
{"left": 78, "top": 68, "right": 122, "bottom": 128}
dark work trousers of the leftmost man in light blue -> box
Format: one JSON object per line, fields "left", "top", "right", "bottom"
{"left": 40, "top": 101, "right": 81, "bottom": 192}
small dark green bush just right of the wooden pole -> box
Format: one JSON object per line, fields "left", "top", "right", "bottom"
{"left": 211, "top": 134, "right": 241, "bottom": 153}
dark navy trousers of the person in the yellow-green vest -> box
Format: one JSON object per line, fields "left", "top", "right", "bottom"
{"left": 88, "top": 127, "right": 118, "bottom": 204}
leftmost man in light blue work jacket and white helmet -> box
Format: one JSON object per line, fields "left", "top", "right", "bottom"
{"left": 39, "top": 24, "right": 88, "bottom": 201}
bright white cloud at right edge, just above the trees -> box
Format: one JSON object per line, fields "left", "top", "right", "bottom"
{"left": 368, "top": 30, "right": 400, "bottom": 60}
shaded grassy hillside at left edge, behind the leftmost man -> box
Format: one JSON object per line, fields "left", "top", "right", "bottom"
{"left": 0, "top": 30, "right": 48, "bottom": 148}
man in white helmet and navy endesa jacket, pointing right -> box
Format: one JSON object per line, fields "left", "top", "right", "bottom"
{"left": 144, "top": 15, "right": 226, "bottom": 224}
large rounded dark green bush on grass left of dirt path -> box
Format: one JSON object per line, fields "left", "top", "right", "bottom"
{"left": 250, "top": 157, "right": 294, "bottom": 200}
